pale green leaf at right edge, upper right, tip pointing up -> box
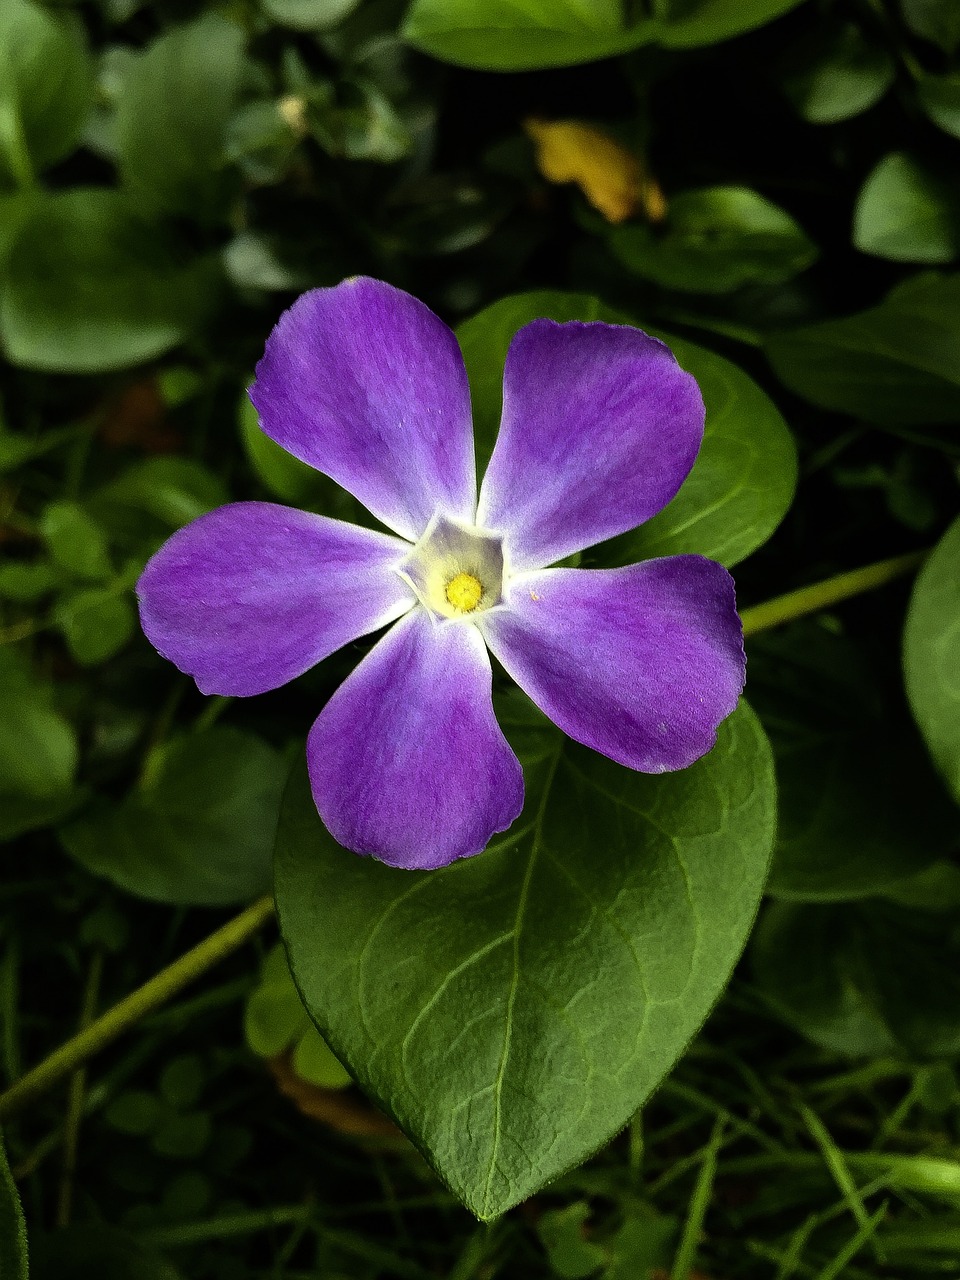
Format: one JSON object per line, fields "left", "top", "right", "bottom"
{"left": 854, "top": 151, "right": 960, "bottom": 262}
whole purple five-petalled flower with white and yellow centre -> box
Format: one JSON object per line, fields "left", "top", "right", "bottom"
{"left": 137, "top": 278, "right": 744, "bottom": 869}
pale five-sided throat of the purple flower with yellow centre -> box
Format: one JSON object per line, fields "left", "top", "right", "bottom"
{"left": 397, "top": 512, "right": 507, "bottom": 621}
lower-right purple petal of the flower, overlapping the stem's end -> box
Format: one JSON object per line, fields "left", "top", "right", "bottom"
{"left": 477, "top": 556, "right": 745, "bottom": 773}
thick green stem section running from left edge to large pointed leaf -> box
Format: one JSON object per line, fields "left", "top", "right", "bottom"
{"left": 0, "top": 897, "right": 274, "bottom": 1117}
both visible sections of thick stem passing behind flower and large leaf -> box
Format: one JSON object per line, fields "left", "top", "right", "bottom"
{"left": 0, "top": 552, "right": 928, "bottom": 1117}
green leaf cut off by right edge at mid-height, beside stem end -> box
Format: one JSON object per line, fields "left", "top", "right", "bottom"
{"left": 904, "top": 520, "right": 960, "bottom": 803}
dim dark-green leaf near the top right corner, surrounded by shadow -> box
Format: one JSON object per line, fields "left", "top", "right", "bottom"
{"left": 783, "top": 23, "right": 895, "bottom": 124}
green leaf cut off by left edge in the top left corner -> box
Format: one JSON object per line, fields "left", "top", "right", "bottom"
{"left": 0, "top": 0, "right": 93, "bottom": 188}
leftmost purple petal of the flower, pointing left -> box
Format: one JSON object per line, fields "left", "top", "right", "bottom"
{"left": 137, "top": 502, "right": 416, "bottom": 698}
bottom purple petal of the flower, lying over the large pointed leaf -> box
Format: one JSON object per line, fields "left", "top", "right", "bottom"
{"left": 307, "top": 609, "right": 524, "bottom": 870}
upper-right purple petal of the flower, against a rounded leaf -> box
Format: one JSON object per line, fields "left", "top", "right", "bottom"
{"left": 477, "top": 320, "right": 704, "bottom": 568}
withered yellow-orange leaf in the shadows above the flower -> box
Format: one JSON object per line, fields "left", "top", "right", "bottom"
{"left": 524, "top": 116, "right": 667, "bottom": 223}
